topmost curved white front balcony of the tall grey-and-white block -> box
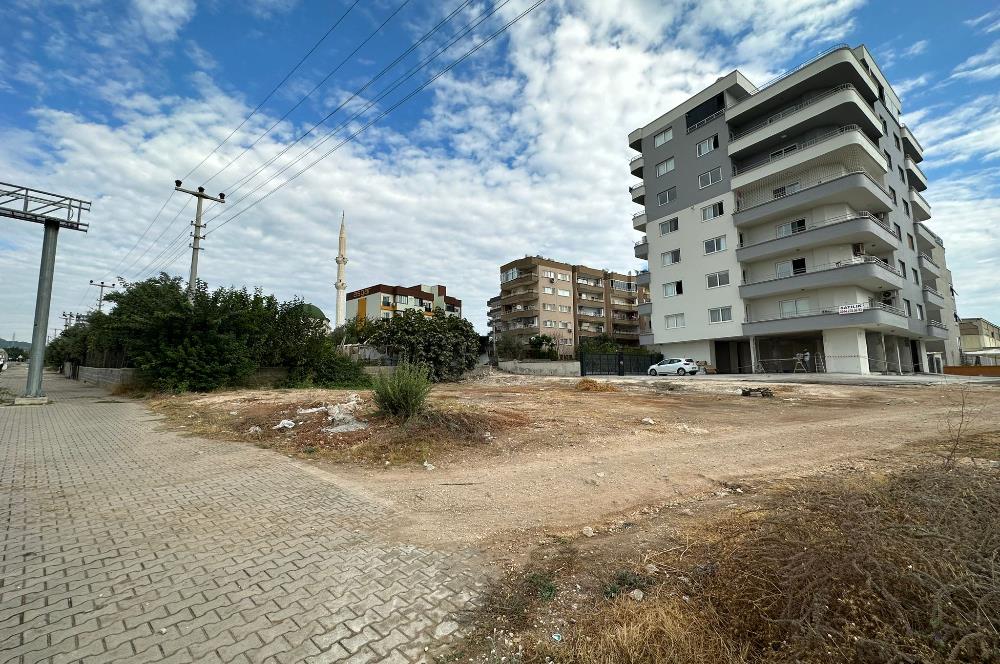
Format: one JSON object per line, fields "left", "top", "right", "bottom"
{"left": 726, "top": 44, "right": 881, "bottom": 127}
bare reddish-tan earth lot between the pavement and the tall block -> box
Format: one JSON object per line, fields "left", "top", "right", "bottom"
{"left": 148, "top": 374, "right": 1000, "bottom": 561}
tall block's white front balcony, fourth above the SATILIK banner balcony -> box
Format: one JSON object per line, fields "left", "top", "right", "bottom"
{"left": 732, "top": 124, "right": 889, "bottom": 193}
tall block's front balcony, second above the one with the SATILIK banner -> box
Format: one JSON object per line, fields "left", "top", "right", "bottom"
{"left": 736, "top": 212, "right": 899, "bottom": 263}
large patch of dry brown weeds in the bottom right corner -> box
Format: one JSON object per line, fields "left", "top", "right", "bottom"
{"left": 525, "top": 466, "right": 1000, "bottom": 664}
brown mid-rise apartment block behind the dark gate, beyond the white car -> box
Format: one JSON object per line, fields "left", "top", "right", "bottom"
{"left": 489, "top": 256, "right": 646, "bottom": 355}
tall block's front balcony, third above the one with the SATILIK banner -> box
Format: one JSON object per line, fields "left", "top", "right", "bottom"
{"left": 733, "top": 168, "right": 893, "bottom": 228}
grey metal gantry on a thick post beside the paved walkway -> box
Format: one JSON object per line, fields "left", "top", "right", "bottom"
{"left": 0, "top": 182, "right": 90, "bottom": 401}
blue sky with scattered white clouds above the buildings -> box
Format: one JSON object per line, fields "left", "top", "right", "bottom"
{"left": 0, "top": 0, "right": 1000, "bottom": 340}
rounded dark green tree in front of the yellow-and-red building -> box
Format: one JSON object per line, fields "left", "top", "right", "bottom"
{"left": 368, "top": 309, "right": 479, "bottom": 382}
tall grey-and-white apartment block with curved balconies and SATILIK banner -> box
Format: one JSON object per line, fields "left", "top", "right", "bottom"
{"left": 628, "top": 46, "right": 958, "bottom": 373}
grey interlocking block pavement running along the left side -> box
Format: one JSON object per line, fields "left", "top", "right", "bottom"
{"left": 0, "top": 368, "right": 482, "bottom": 664}
